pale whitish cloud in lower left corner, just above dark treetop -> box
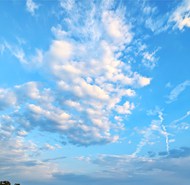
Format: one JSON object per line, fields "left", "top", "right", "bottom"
{"left": 0, "top": 135, "right": 58, "bottom": 181}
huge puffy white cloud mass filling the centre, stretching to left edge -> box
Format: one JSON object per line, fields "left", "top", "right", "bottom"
{"left": 0, "top": 1, "right": 151, "bottom": 146}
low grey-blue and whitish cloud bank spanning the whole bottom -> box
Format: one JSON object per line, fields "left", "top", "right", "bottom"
{"left": 0, "top": 142, "right": 190, "bottom": 185}
